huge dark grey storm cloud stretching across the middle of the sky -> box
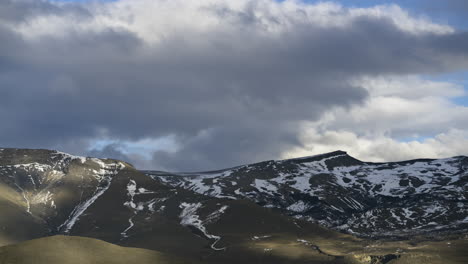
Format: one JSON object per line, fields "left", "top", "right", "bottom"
{"left": 0, "top": 1, "right": 468, "bottom": 170}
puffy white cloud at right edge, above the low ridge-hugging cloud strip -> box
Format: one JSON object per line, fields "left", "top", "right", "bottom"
{"left": 326, "top": 96, "right": 468, "bottom": 138}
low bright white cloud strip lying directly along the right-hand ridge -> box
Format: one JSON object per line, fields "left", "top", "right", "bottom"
{"left": 282, "top": 128, "right": 468, "bottom": 162}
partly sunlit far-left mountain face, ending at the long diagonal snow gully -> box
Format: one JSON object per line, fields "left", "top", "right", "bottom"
{"left": 0, "top": 149, "right": 127, "bottom": 241}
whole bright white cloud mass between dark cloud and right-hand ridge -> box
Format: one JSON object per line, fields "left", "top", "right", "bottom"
{"left": 282, "top": 73, "right": 468, "bottom": 162}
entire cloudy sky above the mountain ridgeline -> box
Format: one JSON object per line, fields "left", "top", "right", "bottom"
{"left": 0, "top": 0, "right": 468, "bottom": 171}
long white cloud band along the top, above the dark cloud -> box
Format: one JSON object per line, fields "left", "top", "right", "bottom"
{"left": 10, "top": 0, "right": 454, "bottom": 43}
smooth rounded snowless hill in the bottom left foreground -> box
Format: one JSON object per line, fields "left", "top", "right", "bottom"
{"left": 0, "top": 236, "right": 192, "bottom": 264}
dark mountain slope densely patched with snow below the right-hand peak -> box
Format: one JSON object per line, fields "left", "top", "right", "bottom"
{"left": 145, "top": 151, "right": 468, "bottom": 237}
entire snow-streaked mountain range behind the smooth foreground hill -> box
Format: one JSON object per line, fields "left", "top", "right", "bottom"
{"left": 0, "top": 149, "right": 468, "bottom": 263}
